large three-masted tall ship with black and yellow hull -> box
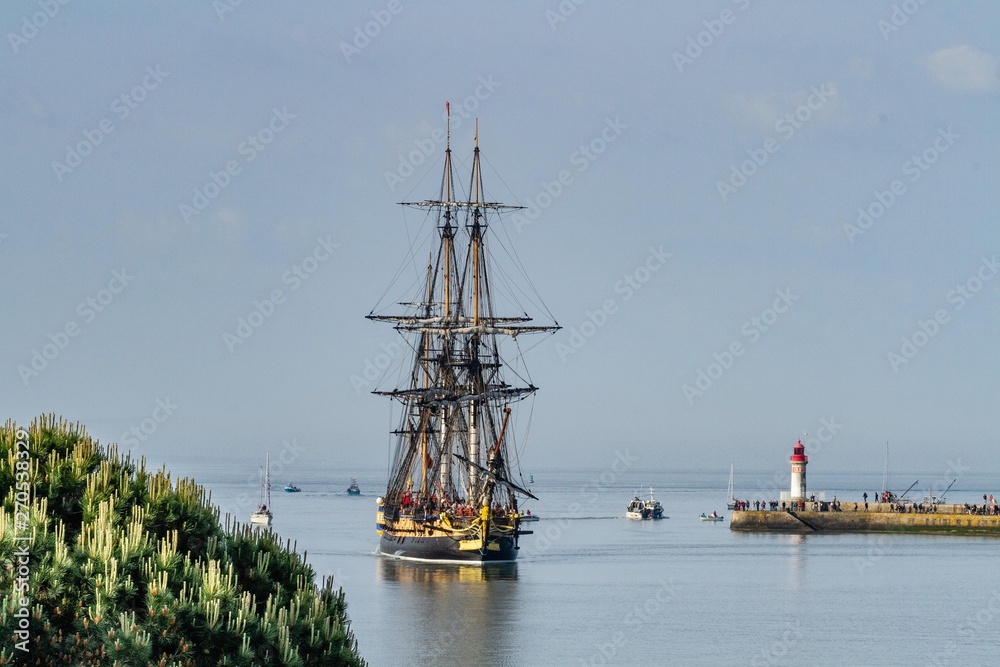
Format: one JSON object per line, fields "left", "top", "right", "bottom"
{"left": 367, "top": 105, "right": 559, "bottom": 565}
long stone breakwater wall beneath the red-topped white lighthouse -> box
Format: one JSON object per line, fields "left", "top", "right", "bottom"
{"left": 729, "top": 503, "right": 1000, "bottom": 536}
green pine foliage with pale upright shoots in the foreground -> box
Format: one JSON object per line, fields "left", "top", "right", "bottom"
{"left": 0, "top": 415, "right": 365, "bottom": 667}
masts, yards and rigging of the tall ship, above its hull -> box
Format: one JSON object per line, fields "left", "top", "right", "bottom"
{"left": 368, "top": 105, "right": 559, "bottom": 549}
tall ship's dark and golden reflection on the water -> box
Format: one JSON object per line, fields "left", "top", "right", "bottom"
{"left": 375, "top": 558, "right": 520, "bottom": 667}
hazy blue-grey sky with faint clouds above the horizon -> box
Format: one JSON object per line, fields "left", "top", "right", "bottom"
{"left": 0, "top": 0, "right": 1000, "bottom": 475}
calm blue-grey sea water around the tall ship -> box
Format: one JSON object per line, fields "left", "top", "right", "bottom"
{"left": 173, "top": 465, "right": 1000, "bottom": 666}
